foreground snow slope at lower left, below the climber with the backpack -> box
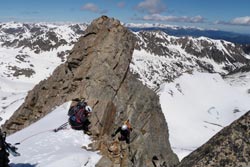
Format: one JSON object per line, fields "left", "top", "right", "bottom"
{"left": 7, "top": 102, "right": 101, "bottom": 167}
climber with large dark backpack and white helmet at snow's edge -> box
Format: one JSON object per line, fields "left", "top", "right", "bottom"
{"left": 68, "top": 99, "right": 92, "bottom": 135}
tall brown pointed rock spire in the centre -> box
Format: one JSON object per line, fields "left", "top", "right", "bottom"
{"left": 1, "top": 16, "right": 178, "bottom": 167}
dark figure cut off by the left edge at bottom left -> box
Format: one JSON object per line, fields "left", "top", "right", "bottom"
{"left": 0, "top": 129, "right": 9, "bottom": 167}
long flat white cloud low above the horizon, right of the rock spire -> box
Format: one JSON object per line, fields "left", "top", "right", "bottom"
{"left": 139, "top": 14, "right": 204, "bottom": 23}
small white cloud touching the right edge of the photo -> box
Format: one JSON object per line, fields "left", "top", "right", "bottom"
{"left": 215, "top": 16, "right": 250, "bottom": 26}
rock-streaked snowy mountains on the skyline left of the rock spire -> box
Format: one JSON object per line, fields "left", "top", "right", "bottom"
{"left": 0, "top": 22, "right": 86, "bottom": 53}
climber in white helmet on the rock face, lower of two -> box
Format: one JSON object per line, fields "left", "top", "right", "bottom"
{"left": 111, "top": 120, "right": 132, "bottom": 144}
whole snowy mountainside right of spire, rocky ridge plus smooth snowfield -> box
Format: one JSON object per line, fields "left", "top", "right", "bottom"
{"left": 130, "top": 31, "right": 250, "bottom": 159}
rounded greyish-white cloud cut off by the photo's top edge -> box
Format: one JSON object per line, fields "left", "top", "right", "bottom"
{"left": 136, "top": 0, "right": 167, "bottom": 14}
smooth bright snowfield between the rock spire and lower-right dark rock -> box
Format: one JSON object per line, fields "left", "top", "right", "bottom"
{"left": 159, "top": 72, "right": 250, "bottom": 159}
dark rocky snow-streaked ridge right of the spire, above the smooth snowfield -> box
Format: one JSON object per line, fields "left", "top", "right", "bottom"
{"left": 131, "top": 31, "right": 250, "bottom": 88}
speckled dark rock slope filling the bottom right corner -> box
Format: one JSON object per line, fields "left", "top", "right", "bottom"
{"left": 178, "top": 111, "right": 250, "bottom": 167}
